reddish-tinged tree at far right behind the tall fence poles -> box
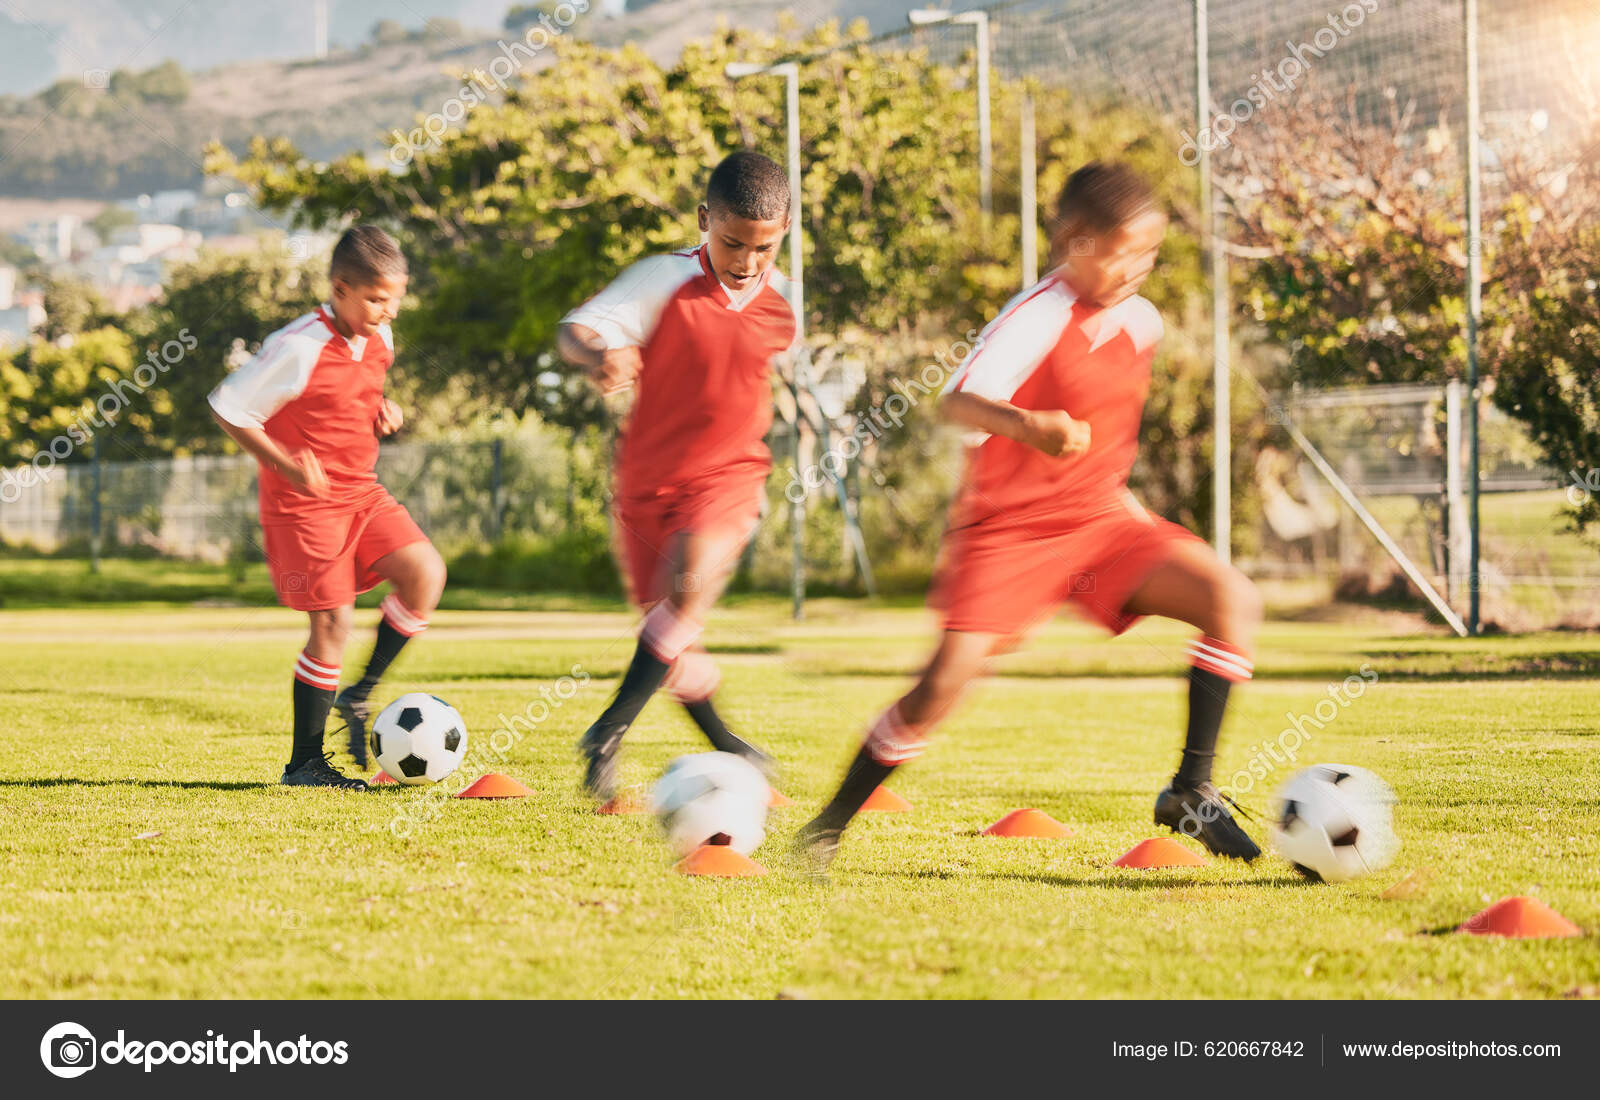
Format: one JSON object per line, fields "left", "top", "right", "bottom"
{"left": 1222, "top": 84, "right": 1600, "bottom": 528}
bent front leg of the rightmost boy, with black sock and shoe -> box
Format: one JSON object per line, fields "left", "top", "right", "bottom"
{"left": 1125, "top": 542, "right": 1261, "bottom": 860}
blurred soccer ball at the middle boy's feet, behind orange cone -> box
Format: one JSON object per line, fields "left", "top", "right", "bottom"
{"left": 650, "top": 753, "right": 768, "bottom": 855}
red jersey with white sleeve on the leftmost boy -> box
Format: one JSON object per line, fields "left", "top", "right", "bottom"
{"left": 210, "top": 305, "right": 394, "bottom": 523}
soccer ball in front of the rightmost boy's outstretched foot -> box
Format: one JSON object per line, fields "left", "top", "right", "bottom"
{"left": 1272, "top": 764, "right": 1400, "bottom": 883}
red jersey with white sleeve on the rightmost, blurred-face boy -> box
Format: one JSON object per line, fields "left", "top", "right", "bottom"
{"left": 944, "top": 275, "right": 1162, "bottom": 531}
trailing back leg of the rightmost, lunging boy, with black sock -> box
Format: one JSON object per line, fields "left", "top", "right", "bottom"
{"left": 795, "top": 630, "right": 1002, "bottom": 870}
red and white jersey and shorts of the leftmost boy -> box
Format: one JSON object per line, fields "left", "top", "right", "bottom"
{"left": 210, "top": 305, "right": 426, "bottom": 611}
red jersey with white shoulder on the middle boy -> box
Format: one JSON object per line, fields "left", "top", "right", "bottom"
{"left": 565, "top": 245, "right": 795, "bottom": 496}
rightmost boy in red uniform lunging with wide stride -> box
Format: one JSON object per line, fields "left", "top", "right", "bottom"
{"left": 797, "top": 163, "right": 1261, "bottom": 868}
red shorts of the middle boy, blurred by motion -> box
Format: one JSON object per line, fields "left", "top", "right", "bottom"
{"left": 611, "top": 470, "right": 766, "bottom": 608}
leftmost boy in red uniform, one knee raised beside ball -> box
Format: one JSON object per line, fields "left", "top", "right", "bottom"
{"left": 211, "top": 225, "right": 445, "bottom": 790}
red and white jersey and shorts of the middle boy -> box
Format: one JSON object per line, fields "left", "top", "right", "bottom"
{"left": 563, "top": 246, "right": 795, "bottom": 606}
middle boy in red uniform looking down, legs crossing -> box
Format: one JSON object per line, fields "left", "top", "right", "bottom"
{"left": 560, "top": 152, "right": 795, "bottom": 801}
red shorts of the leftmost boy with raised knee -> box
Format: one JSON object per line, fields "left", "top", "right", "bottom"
{"left": 261, "top": 486, "right": 427, "bottom": 611}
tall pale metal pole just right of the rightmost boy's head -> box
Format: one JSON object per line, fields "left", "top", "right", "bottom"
{"left": 1195, "top": 0, "right": 1234, "bottom": 564}
